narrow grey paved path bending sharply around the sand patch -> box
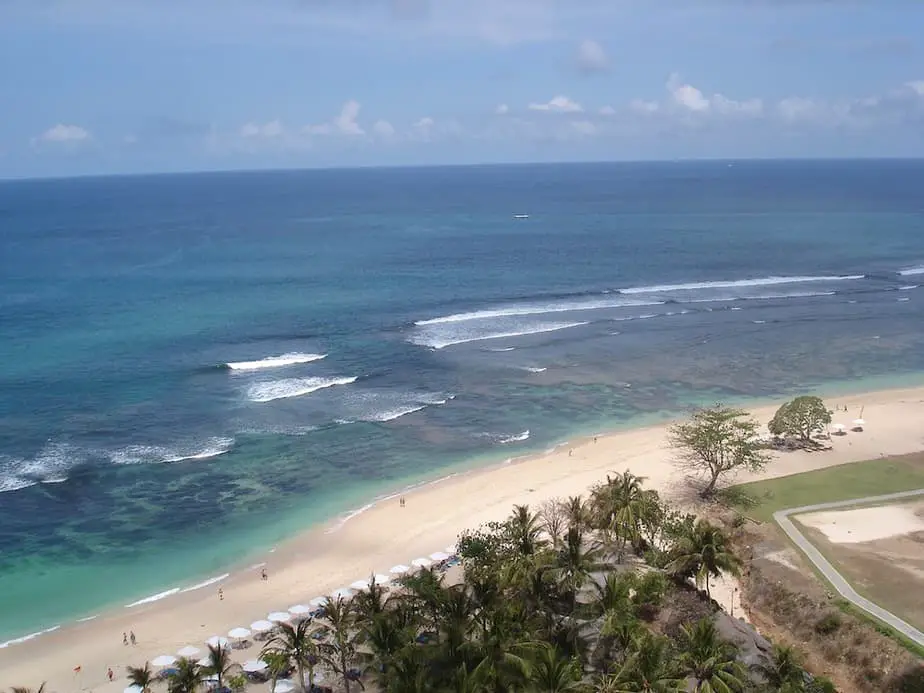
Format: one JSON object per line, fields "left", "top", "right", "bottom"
{"left": 773, "top": 489, "right": 924, "bottom": 647}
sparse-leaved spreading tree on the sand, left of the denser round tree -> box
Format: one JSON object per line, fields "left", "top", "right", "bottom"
{"left": 668, "top": 404, "right": 771, "bottom": 498}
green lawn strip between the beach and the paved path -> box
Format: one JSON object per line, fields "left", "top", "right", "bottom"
{"left": 723, "top": 452, "right": 924, "bottom": 522}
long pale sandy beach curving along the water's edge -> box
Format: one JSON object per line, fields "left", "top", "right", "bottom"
{"left": 0, "top": 388, "right": 924, "bottom": 693}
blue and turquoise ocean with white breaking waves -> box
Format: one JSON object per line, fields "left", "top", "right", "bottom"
{"left": 0, "top": 161, "right": 924, "bottom": 641}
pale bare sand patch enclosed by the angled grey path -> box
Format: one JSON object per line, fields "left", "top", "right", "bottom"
{"left": 795, "top": 505, "right": 924, "bottom": 544}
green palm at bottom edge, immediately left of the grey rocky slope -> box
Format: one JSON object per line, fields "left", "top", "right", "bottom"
{"left": 680, "top": 618, "right": 747, "bottom": 693}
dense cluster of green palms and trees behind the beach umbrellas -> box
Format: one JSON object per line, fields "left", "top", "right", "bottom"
{"left": 99, "top": 472, "right": 833, "bottom": 693}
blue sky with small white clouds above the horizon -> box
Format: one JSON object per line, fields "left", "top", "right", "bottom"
{"left": 0, "top": 0, "right": 924, "bottom": 177}
